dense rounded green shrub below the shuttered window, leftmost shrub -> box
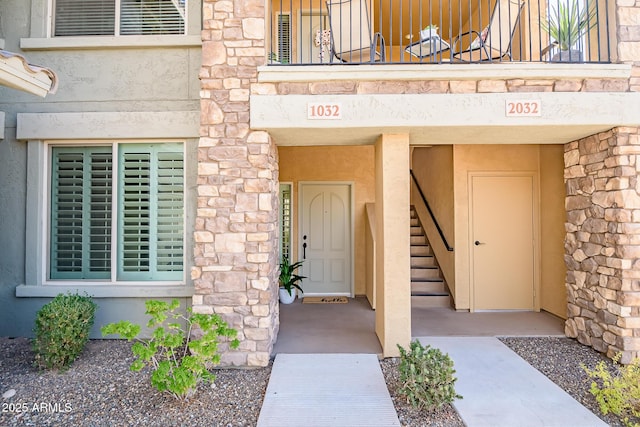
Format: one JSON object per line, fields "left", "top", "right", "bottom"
{"left": 33, "top": 294, "right": 97, "bottom": 370}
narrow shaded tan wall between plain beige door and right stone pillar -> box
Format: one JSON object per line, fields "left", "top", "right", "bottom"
{"left": 540, "top": 145, "right": 567, "bottom": 319}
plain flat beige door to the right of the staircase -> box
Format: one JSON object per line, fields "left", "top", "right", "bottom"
{"left": 470, "top": 175, "right": 536, "bottom": 310}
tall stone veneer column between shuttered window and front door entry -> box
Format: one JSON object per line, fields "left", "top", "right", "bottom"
{"left": 191, "top": 0, "right": 279, "bottom": 366}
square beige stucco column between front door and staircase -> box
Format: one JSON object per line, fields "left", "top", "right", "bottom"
{"left": 375, "top": 134, "right": 411, "bottom": 357}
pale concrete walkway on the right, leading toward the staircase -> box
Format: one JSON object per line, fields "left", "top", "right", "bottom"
{"left": 418, "top": 337, "right": 607, "bottom": 427}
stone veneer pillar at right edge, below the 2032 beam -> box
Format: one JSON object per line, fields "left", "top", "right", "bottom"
{"left": 564, "top": 128, "right": 640, "bottom": 363}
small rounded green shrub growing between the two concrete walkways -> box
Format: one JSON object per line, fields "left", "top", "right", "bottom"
{"left": 398, "top": 341, "right": 462, "bottom": 411}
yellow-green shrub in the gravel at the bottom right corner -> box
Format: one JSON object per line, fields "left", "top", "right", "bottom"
{"left": 581, "top": 354, "right": 640, "bottom": 427}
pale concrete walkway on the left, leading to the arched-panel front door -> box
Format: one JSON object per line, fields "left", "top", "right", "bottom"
{"left": 258, "top": 353, "right": 400, "bottom": 427}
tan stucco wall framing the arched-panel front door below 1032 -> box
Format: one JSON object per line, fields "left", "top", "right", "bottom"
{"left": 278, "top": 146, "right": 375, "bottom": 295}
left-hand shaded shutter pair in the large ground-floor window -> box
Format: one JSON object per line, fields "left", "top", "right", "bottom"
{"left": 50, "top": 147, "right": 112, "bottom": 279}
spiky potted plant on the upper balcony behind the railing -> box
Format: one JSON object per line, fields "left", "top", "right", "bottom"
{"left": 541, "top": 0, "right": 596, "bottom": 62}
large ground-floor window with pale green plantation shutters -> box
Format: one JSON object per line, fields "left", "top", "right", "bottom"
{"left": 49, "top": 143, "right": 184, "bottom": 281}
